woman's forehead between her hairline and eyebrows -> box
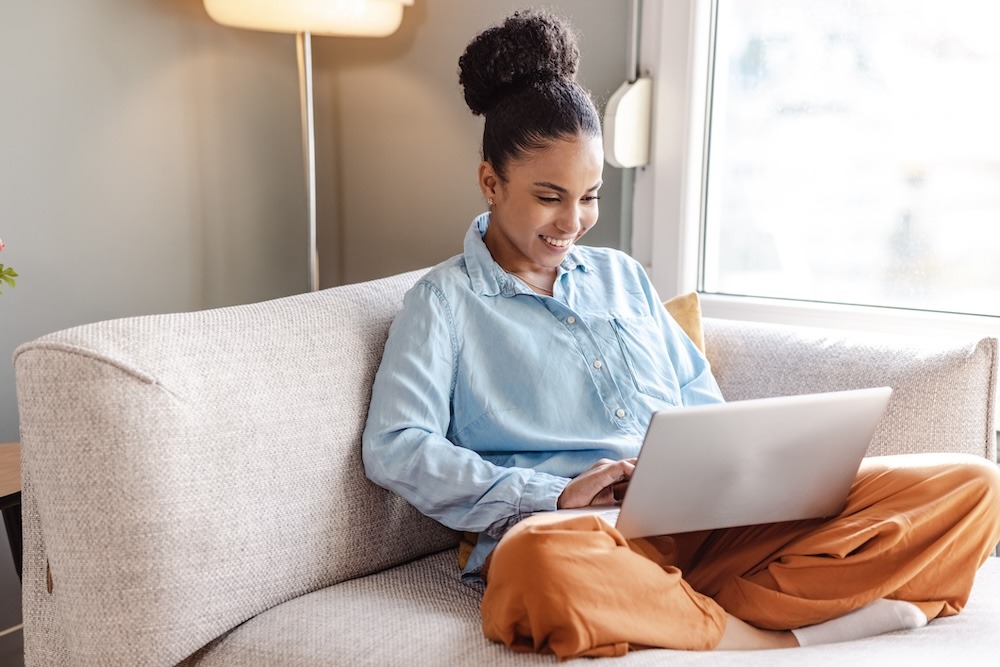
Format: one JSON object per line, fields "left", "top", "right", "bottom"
{"left": 507, "top": 136, "right": 604, "bottom": 190}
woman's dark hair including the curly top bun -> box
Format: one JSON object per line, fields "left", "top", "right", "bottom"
{"left": 458, "top": 10, "right": 601, "bottom": 178}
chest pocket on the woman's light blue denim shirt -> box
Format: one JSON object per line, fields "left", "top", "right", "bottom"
{"left": 611, "top": 317, "right": 680, "bottom": 405}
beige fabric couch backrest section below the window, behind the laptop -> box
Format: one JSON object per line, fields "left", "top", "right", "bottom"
{"left": 704, "top": 319, "right": 997, "bottom": 461}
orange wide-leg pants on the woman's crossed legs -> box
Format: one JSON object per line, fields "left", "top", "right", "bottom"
{"left": 481, "top": 454, "right": 1000, "bottom": 659}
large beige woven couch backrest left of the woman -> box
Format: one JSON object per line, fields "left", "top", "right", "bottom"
{"left": 15, "top": 272, "right": 457, "bottom": 665}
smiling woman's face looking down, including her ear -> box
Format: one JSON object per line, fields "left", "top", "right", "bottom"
{"left": 479, "top": 136, "right": 604, "bottom": 273}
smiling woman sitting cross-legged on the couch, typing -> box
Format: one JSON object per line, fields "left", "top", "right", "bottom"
{"left": 363, "top": 7, "right": 1000, "bottom": 658}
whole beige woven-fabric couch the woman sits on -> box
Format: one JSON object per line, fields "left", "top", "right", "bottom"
{"left": 15, "top": 273, "right": 1000, "bottom": 667}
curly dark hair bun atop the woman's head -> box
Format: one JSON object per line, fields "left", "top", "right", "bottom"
{"left": 458, "top": 10, "right": 580, "bottom": 116}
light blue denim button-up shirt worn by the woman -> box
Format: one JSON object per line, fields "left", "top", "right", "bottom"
{"left": 363, "top": 213, "right": 722, "bottom": 575}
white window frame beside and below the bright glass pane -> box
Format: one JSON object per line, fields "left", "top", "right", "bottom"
{"left": 631, "top": 0, "right": 1000, "bottom": 337}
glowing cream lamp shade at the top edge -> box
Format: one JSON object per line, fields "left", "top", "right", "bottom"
{"left": 205, "top": 0, "right": 413, "bottom": 37}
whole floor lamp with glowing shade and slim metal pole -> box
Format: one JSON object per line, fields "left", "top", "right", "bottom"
{"left": 204, "top": 0, "right": 413, "bottom": 292}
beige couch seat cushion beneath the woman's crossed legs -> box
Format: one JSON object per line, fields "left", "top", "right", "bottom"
{"left": 185, "top": 550, "right": 1000, "bottom": 667}
